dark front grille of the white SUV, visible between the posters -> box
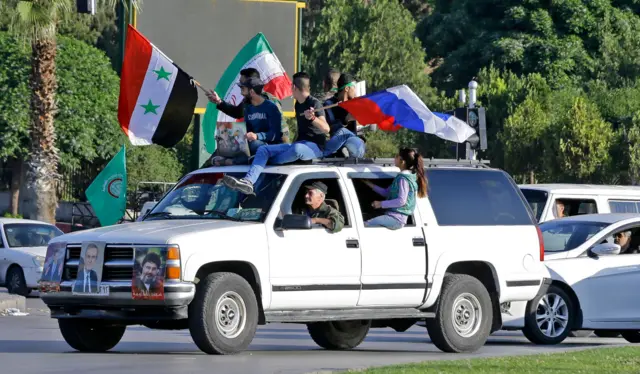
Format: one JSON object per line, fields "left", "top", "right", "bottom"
{"left": 62, "top": 244, "right": 135, "bottom": 281}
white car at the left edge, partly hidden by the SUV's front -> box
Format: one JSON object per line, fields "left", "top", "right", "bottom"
{"left": 0, "top": 218, "right": 64, "bottom": 296}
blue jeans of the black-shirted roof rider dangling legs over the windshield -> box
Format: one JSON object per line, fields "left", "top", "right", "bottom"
{"left": 244, "top": 141, "right": 322, "bottom": 184}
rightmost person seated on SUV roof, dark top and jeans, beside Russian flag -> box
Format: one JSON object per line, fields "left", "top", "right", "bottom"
{"left": 323, "top": 73, "right": 365, "bottom": 158}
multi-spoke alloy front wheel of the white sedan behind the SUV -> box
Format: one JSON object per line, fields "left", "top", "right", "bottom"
{"left": 522, "top": 284, "right": 575, "bottom": 345}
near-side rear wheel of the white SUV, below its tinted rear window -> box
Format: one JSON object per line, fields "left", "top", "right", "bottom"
{"left": 426, "top": 274, "right": 493, "bottom": 353}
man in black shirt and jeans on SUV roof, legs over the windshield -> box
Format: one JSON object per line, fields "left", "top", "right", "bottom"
{"left": 222, "top": 72, "right": 329, "bottom": 195}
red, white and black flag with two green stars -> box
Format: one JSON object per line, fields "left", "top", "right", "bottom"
{"left": 118, "top": 25, "right": 198, "bottom": 148}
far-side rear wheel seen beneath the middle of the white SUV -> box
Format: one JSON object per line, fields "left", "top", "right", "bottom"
{"left": 307, "top": 320, "right": 371, "bottom": 350}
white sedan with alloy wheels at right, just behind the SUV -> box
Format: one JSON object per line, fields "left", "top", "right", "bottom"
{"left": 501, "top": 213, "right": 640, "bottom": 344}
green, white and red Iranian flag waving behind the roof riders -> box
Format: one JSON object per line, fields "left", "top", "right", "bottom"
{"left": 202, "top": 33, "right": 291, "bottom": 153}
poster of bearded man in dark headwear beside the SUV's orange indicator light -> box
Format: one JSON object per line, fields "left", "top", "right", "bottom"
{"left": 131, "top": 248, "right": 167, "bottom": 300}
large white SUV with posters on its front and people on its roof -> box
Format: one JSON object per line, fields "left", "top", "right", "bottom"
{"left": 42, "top": 160, "right": 549, "bottom": 354}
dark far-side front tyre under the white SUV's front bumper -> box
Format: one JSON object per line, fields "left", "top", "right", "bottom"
{"left": 58, "top": 319, "right": 127, "bottom": 352}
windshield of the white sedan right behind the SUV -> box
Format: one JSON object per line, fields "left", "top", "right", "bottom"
{"left": 540, "top": 220, "right": 609, "bottom": 252}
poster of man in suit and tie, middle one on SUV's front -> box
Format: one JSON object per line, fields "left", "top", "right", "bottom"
{"left": 73, "top": 242, "right": 108, "bottom": 295}
